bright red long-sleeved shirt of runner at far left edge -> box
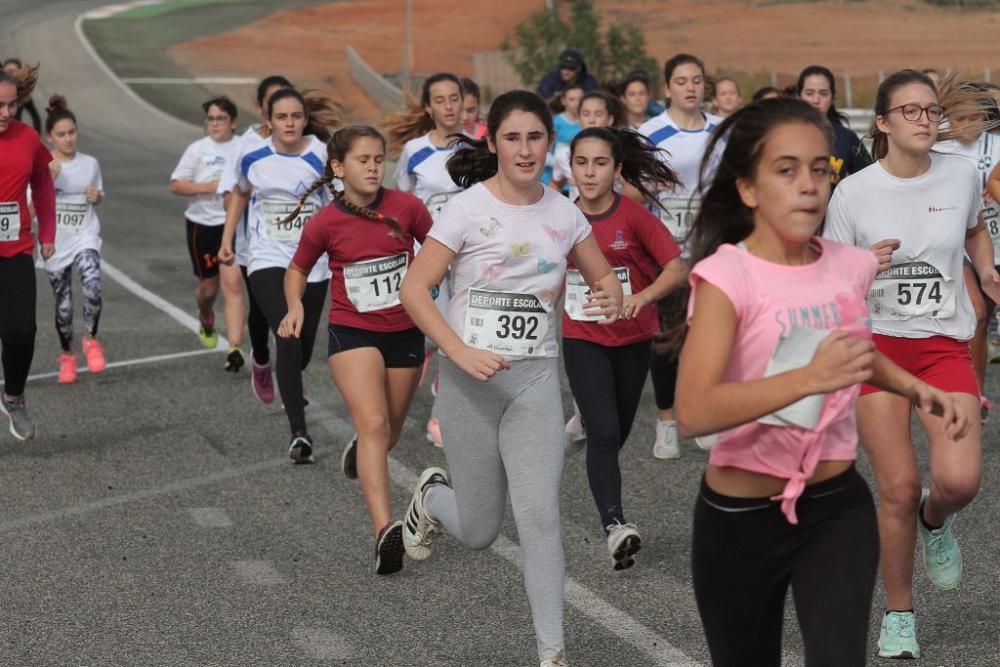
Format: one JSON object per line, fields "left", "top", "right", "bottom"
{"left": 0, "top": 120, "right": 56, "bottom": 257}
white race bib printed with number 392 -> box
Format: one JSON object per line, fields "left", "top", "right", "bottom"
{"left": 464, "top": 289, "right": 549, "bottom": 357}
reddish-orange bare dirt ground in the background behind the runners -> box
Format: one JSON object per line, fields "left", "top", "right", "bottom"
{"left": 170, "top": 0, "right": 1000, "bottom": 119}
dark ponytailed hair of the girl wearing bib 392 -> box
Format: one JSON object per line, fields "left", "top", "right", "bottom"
{"left": 447, "top": 90, "right": 553, "bottom": 188}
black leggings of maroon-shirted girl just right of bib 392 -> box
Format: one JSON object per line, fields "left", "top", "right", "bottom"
{"left": 563, "top": 338, "right": 649, "bottom": 527}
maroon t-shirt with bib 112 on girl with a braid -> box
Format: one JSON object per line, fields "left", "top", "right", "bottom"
{"left": 292, "top": 188, "right": 431, "bottom": 331}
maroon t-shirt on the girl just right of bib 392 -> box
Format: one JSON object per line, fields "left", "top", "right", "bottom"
{"left": 563, "top": 195, "right": 681, "bottom": 347}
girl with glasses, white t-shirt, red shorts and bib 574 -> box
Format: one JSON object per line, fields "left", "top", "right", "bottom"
{"left": 824, "top": 70, "right": 1000, "bottom": 658}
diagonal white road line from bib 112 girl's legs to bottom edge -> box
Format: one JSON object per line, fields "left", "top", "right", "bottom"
{"left": 318, "top": 404, "right": 701, "bottom": 667}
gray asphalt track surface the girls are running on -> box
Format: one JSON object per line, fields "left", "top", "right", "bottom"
{"left": 0, "top": 0, "right": 1000, "bottom": 667}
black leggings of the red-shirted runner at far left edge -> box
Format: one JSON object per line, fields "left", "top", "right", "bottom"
{"left": 0, "top": 253, "right": 38, "bottom": 396}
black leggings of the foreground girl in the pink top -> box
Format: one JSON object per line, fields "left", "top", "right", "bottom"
{"left": 691, "top": 468, "right": 878, "bottom": 667}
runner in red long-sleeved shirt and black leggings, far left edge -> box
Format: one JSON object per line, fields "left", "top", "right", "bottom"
{"left": 0, "top": 66, "right": 56, "bottom": 440}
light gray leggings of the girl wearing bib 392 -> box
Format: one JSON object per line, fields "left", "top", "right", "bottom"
{"left": 426, "top": 358, "right": 566, "bottom": 660}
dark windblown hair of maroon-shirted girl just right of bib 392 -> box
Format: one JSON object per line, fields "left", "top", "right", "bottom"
{"left": 569, "top": 127, "right": 679, "bottom": 201}
